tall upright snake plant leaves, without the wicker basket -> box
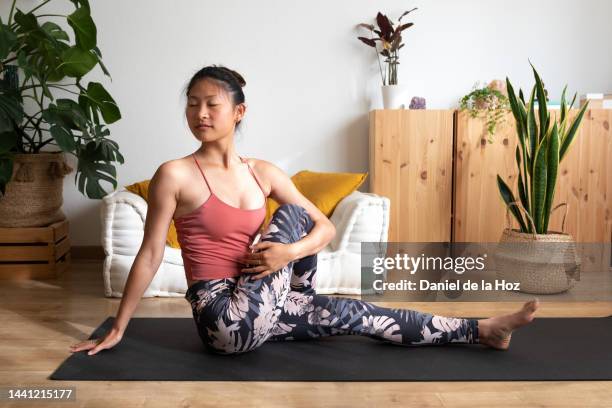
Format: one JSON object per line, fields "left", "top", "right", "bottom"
{"left": 497, "top": 63, "right": 588, "bottom": 234}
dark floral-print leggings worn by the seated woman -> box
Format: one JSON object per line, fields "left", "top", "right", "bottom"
{"left": 185, "top": 204, "right": 478, "bottom": 354}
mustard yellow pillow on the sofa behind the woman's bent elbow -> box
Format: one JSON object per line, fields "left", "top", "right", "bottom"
{"left": 264, "top": 170, "right": 368, "bottom": 230}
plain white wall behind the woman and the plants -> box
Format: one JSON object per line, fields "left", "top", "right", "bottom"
{"left": 0, "top": 0, "right": 612, "bottom": 245}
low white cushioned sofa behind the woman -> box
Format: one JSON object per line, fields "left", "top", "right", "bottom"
{"left": 100, "top": 188, "right": 390, "bottom": 297}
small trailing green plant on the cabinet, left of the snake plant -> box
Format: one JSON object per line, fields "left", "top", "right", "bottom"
{"left": 459, "top": 80, "right": 510, "bottom": 143}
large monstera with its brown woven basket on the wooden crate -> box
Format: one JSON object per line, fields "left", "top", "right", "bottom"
{"left": 0, "top": 0, "right": 123, "bottom": 227}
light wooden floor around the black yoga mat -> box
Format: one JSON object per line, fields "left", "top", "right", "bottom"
{"left": 0, "top": 261, "right": 612, "bottom": 407}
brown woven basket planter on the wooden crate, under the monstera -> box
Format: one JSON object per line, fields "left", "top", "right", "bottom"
{"left": 0, "top": 152, "right": 72, "bottom": 227}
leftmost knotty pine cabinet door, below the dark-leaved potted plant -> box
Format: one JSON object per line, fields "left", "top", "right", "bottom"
{"left": 369, "top": 109, "right": 453, "bottom": 242}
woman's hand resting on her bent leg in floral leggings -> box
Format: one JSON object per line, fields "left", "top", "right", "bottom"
{"left": 240, "top": 241, "right": 294, "bottom": 279}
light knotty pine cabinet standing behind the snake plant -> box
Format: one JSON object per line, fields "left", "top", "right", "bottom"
{"left": 369, "top": 109, "right": 612, "bottom": 243}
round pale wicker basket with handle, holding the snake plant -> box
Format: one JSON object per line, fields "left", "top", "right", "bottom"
{"left": 495, "top": 203, "right": 580, "bottom": 294}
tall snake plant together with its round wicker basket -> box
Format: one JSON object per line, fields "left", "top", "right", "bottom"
{"left": 496, "top": 65, "right": 588, "bottom": 294}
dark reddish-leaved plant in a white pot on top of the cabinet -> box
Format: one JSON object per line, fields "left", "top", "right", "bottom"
{"left": 357, "top": 7, "right": 416, "bottom": 109}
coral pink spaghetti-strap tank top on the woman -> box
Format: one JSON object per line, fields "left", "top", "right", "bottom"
{"left": 174, "top": 155, "right": 267, "bottom": 280}
